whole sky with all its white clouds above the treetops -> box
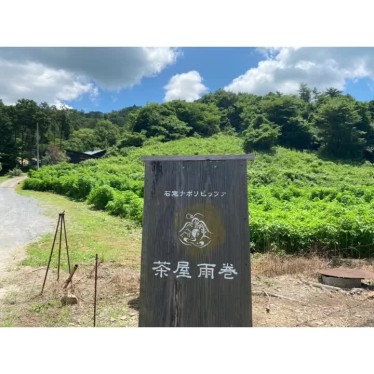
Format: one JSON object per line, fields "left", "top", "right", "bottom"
{"left": 0, "top": 47, "right": 374, "bottom": 112}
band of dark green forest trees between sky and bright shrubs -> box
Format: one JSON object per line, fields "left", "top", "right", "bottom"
{"left": 0, "top": 84, "right": 374, "bottom": 173}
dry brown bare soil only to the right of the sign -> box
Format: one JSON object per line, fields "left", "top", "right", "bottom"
{"left": 252, "top": 275, "right": 374, "bottom": 327}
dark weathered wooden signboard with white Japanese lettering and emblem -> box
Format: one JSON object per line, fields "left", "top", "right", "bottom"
{"left": 139, "top": 155, "right": 252, "bottom": 327}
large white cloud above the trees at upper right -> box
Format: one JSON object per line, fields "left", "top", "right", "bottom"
{"left": 224, "top": 48, "right": 374, "bottom": 95}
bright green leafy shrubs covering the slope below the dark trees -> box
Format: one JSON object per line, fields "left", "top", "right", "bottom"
{"left": 24, "top": 135, "right": 374, "bottom": 257}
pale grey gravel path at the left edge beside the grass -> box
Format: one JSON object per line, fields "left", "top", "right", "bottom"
{"left": 0, "top": 177, "right": 53, "bottom": 257}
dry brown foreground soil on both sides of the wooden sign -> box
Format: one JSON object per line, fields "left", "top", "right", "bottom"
{"left": 0, "top": 251, "right": 374, "bottom": 327}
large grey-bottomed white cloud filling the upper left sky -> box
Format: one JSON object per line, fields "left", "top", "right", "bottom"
{"left": 0, "top": 47, "right": 179, "bottom": 105}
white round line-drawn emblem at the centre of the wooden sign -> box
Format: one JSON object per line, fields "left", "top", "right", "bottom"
{"left": 179, "top": 213, "right": 212, "bottom": 248}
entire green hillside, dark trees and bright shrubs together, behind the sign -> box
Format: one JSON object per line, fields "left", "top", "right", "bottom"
{"left": 0, "top": 85, "right": 374, "bottom": 257}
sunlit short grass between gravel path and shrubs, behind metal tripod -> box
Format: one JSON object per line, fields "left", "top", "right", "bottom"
{"left": 17, "top": 186, "right": 141, "bottom": 270}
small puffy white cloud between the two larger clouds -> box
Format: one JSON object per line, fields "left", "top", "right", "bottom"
{"left": 164, "top": 70, "right": 208, "bottom": 101}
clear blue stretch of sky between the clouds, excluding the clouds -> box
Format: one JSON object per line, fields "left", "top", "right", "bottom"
{"left": 68, "top": 47, "right": 260, "bottom": 111}
